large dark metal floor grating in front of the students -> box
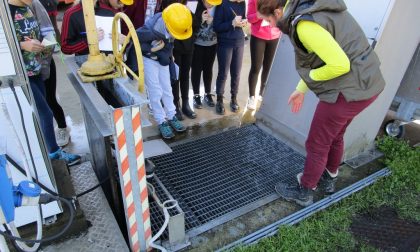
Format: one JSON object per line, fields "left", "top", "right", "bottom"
{"left": 152, "top": 125, "right": 304, "bottom": 236}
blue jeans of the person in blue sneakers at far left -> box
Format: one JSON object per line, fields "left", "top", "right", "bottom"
{"left": 29, "top": 76, "right": 60, "bottom": 153}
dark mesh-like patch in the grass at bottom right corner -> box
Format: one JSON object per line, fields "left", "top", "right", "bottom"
{"left": 350, "top": 207, "right": 420, "bottom": 252}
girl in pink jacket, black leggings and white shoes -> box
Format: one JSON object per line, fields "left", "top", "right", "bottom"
{"left": 246, "top": 0, "right": 281, "bottom": 110}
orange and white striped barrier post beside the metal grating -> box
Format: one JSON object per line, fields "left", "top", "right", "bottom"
{"left": 113, "top": 106, "right": 152, "bottom": 252}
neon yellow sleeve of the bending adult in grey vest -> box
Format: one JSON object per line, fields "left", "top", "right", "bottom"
{"left": 296, "top": 20, "right": 350, "bottom": 93}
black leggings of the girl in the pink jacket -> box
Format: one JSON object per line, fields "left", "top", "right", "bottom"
{"left": 248, "top": 36, "right": 279, "bottom": 96}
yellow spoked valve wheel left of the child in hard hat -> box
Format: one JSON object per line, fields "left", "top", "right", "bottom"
{"left": 112, "top": 12, "right": 144, "bottom": 93}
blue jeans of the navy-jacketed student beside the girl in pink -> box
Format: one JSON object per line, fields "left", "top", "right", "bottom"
{"left": 216, "top": 46, "right": 244, "bottom": 96}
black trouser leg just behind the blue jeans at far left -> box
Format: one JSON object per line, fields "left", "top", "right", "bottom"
{"left": 44, "top": 59, "right": 67, "bottom": 129}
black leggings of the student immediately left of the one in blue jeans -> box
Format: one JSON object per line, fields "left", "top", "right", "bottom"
{"left": 191, "top": 45, "right": 217, "bottom": 94}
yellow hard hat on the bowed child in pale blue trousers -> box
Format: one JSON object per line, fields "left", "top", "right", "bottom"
{"left": 162, "top": 3, "right": 192, "bottom": 40}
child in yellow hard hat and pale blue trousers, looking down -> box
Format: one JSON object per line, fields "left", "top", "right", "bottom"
{"left": 137, "top": 3, "right": 192, "bottom": 139}
